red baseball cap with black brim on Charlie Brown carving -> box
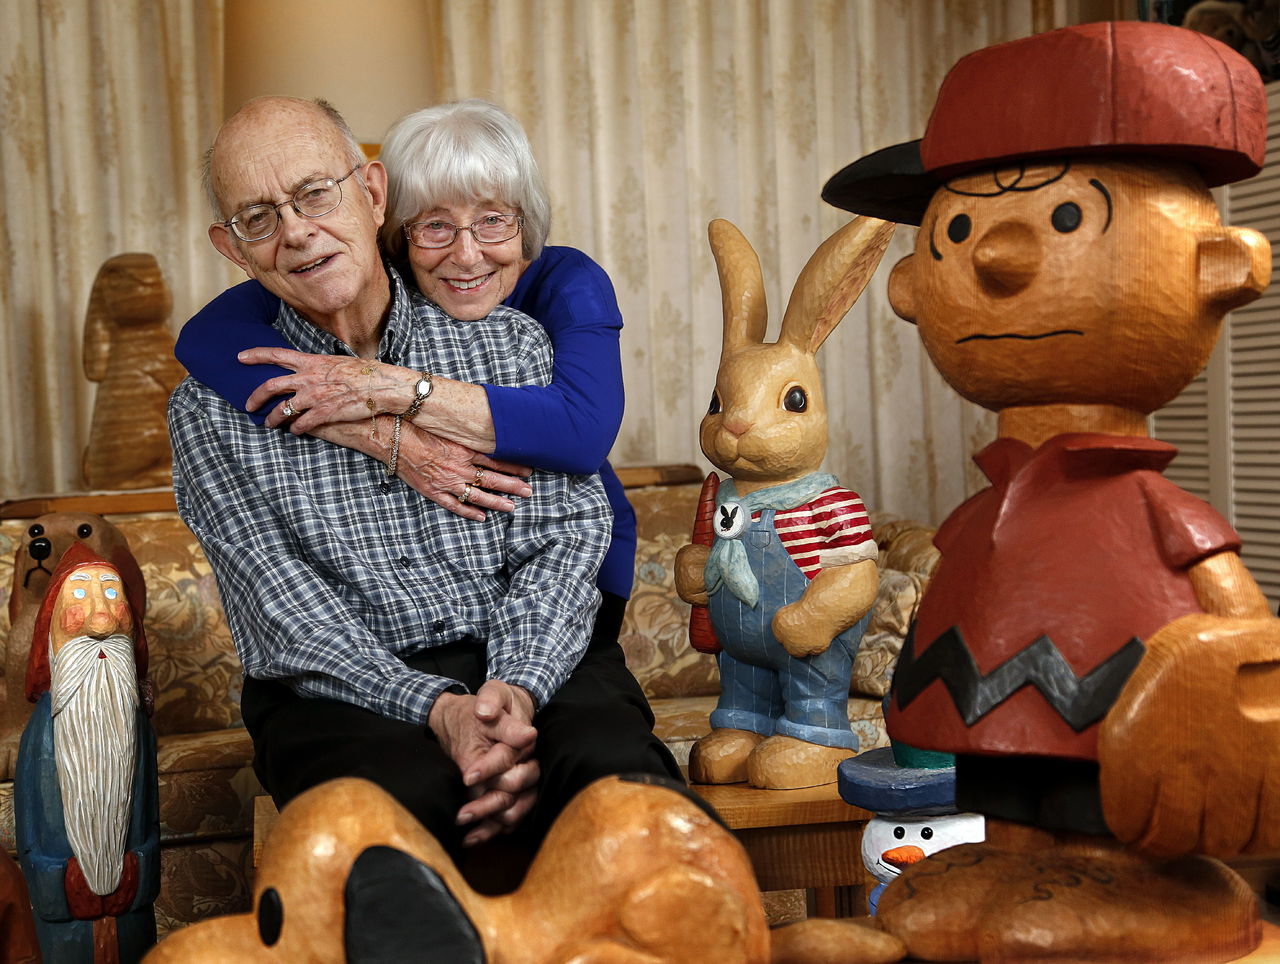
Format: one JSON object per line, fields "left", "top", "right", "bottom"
{"left": 822, "top": 20, "right": 1266, "bottom": 224}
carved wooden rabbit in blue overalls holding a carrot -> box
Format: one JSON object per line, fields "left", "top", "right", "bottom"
{"left": 676, "top": 218, "right": 893, "bottom": 789}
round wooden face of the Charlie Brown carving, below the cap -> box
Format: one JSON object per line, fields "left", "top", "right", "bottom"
{"left": 890, "top": 160, "right": 1219, "bottom": 411}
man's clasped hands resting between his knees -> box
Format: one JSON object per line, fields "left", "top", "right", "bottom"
{"left": 428, "top": 680, "right": 540, "bottom": 846}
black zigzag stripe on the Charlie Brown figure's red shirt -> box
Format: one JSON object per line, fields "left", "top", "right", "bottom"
{"left": 893, "top": 623, "right": 1147, "bottom": 732}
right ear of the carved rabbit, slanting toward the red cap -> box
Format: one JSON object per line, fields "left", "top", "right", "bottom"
{"left": 778, "top": 218, "right": 897, "bottom": 355}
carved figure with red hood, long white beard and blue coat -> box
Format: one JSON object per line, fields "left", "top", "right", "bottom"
{"left": 14, "top": 543, "right": 160, "bottom": 964}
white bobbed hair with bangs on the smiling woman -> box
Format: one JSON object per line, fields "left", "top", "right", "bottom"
{"left": 378, "top": 100, "right": 552, "bottom": 262}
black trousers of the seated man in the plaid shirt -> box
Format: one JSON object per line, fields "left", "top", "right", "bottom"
{"left": 241, "top": 593, "right": 684, "bottom": 855}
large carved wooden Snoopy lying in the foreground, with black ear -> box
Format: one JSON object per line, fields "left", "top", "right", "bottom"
{"left": 146, "top": 777, "right": 905, "bottom": 964}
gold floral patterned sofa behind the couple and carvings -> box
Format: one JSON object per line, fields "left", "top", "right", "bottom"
{"left": 0, "top": 466, "right": 936, "bottom": 932}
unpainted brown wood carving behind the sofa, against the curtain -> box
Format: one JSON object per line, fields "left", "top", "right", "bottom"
{"left": 83, "top": 253, "right": 186, "bottom": 489}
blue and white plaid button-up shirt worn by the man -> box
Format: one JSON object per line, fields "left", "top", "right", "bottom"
{"left": 169, "top": 269, "right": 611, "bottom": 723}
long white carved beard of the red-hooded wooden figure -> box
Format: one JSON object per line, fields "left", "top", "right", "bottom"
{"left": 50, "top": 635, "right": 138, "bottom": 896}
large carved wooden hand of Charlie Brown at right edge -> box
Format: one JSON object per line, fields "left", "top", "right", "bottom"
{"left": 1098, "top": 613, "right": 1280, "bottom": 856}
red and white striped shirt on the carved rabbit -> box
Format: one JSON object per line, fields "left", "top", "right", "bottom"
{"left": 755, "top": 485, "right": 879, "bottom": 579}
